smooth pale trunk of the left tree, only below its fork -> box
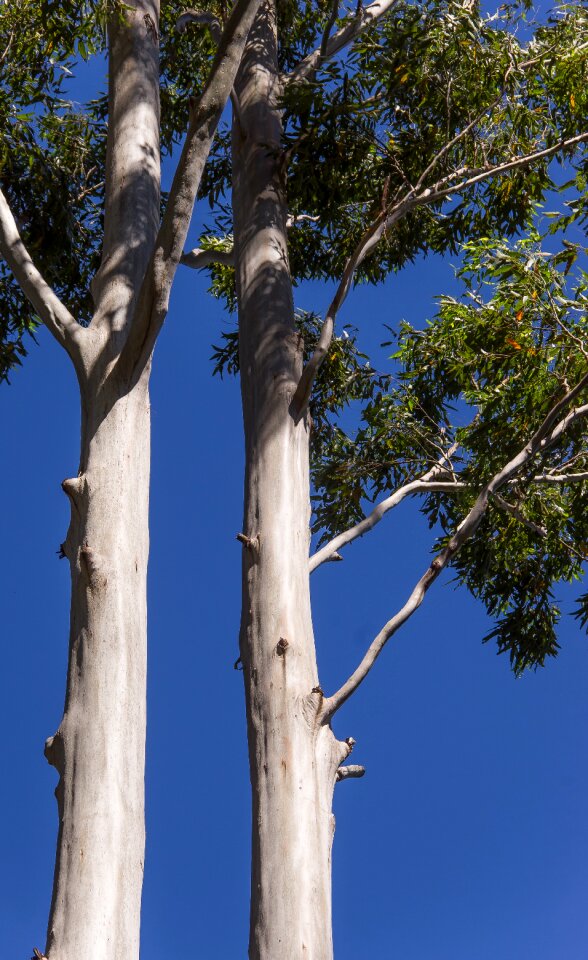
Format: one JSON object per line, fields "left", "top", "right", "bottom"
{"left": 45, "top": 372, "right": 149, "bottom": 960}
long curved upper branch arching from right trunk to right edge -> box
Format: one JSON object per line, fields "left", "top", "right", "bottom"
{"left": 292, "top": 131, "right": 588, "bottom": 419}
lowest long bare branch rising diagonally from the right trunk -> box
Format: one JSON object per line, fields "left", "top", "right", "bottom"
{"left": 322, "top": 373, "right": 588, "bottom": 719}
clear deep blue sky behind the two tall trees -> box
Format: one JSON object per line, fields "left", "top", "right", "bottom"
{"left": 0, "top": 33, "right": 588, "bottom": 960}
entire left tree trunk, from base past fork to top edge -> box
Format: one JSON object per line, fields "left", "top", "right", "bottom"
{"left": 45, "top": 0, "right": 160, "bottom": 960}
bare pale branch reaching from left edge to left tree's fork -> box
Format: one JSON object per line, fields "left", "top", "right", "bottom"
{"left": 0, "top": 190, "right": 83, "bottom": 370}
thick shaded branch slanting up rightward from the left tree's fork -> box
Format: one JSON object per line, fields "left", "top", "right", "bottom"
{"left": 119, "top": 0, "right": 260, "bottom": 376}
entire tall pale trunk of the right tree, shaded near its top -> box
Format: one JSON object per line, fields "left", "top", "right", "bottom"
{"left": 233, "top": 0, "right": 349, "bottom": 960}
